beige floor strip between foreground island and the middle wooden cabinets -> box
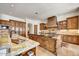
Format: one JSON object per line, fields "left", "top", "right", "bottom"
{"left": 36, "top": 46, "right": 55, "bottom": 56}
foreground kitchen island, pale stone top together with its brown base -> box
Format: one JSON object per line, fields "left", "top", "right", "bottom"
{"left": 7, "top": 36, "right": 40, "bottom": 56}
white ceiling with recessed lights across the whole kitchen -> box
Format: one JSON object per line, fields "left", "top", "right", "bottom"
{"left": 0, "top": 3, "right": 79, "bottom": 19}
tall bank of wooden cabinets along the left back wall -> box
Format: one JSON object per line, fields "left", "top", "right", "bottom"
{"left": 10, "top": 20, "right": 26, "bottom": 37}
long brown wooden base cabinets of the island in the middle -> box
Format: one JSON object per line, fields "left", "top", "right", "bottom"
{"left": 29, "top": 34, "right": 56, "bottom": 53}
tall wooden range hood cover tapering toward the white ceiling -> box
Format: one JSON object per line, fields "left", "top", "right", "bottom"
{"left": 47, "top": 16, "right": 57, "bottom": 28}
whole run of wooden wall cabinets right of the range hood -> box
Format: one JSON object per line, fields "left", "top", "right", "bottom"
{"left": 58, "top": 16, "right": 79, "bottom": 30}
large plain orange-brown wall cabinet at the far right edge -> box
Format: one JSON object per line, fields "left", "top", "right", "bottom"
{"left": 67, "top": 16, "right": 79, "bottom": 29}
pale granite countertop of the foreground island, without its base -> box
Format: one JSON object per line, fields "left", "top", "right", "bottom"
{"left": 8, "top": 36, "right": 40, "bottom": 56}
